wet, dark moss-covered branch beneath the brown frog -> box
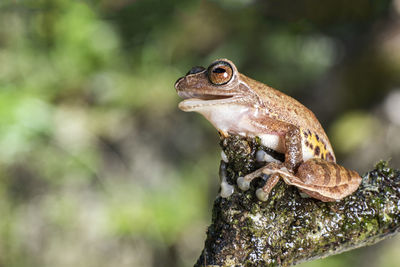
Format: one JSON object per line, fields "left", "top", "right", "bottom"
{"left": 195, "top": 136, "right": 400, "bottom": 266}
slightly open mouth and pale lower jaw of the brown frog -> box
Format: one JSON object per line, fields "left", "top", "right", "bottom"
{"left": 178, "top": 91, "right": 237, "bottom": 111}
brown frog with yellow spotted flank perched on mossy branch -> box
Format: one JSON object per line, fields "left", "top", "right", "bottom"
{"left": 175, "top": 58, "right": 362, "bottom": 202}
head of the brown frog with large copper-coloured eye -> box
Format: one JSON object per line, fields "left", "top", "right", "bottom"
{"left": 175, "top": 59, "right": 255, "bottom": 113}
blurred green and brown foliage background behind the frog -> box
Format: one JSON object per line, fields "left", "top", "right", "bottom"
{"left": 0, "top": 0, "right": 400, "bottom": 267}
